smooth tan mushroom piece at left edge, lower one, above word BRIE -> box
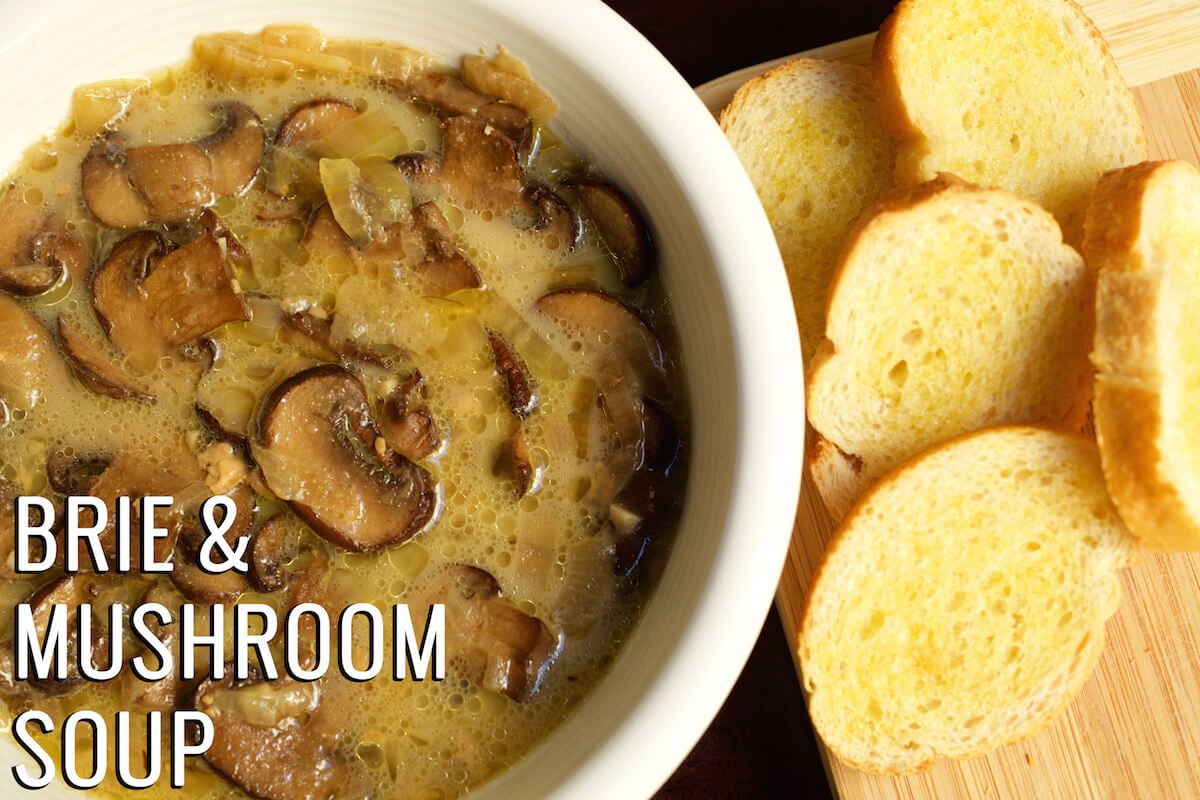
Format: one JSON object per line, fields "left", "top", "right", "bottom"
{"left": 0, "top": 295, "right": 71, "bottom": 414}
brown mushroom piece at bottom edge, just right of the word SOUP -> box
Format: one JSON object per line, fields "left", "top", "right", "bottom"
{"left": 194, "top": 664, "right": 367, "bottom": 800}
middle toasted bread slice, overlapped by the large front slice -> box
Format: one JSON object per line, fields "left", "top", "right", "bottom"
{"left": 808, "top": 175, "right": 1094, "bottom": 519}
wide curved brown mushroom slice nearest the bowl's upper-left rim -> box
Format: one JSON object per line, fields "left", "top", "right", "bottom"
{"left": 82, "top": 102, "right": 264, "bottom": 229}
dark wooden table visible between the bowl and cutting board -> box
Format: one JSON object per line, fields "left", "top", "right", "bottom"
{"left": 592, "top": 0, "right": 894, "bottom": 800}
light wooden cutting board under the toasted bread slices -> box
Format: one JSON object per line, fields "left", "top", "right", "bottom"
{"left": 697, "top": 0, "right": 1200, "bottom": 800}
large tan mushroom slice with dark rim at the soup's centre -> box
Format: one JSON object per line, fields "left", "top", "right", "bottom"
{"left": 250, "top": 365, "right": 438, "bottom": 551}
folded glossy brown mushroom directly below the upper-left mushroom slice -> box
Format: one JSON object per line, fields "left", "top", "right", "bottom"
{"left": 92, "top": 230, "right": 247, "bottom": 371}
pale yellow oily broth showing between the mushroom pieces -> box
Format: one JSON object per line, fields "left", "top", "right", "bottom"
{"left": 0, "top": 31, "right": 685, "bottom": 799}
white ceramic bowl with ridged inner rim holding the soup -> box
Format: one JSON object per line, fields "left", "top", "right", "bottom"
{"left": 0, "top": 0, "right": 804, "bottom": 800}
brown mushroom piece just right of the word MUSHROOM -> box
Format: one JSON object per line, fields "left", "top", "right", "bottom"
{"left": 426, "top": 564, "right": 562, "bottom": 702}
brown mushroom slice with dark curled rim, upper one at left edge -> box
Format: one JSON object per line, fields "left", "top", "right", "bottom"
{"left": 0, "top": 186, "right": 91, "bottom": 297}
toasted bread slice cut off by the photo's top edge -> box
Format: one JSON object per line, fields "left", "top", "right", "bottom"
{"left": 874, "top": 0, "right": 1146, "bottom": 246}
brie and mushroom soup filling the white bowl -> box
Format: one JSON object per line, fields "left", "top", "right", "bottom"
{"left": 0, "top": 26, "right": 686, "bottom": 800}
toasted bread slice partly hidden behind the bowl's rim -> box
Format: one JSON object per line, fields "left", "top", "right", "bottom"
{"left": 721, "top": 59, "right": 895, "bottom": 363}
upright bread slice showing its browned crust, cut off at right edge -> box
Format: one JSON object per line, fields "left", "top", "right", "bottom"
{"left": 1084, "top": 161, "right": 1200, "bottom": 551}
